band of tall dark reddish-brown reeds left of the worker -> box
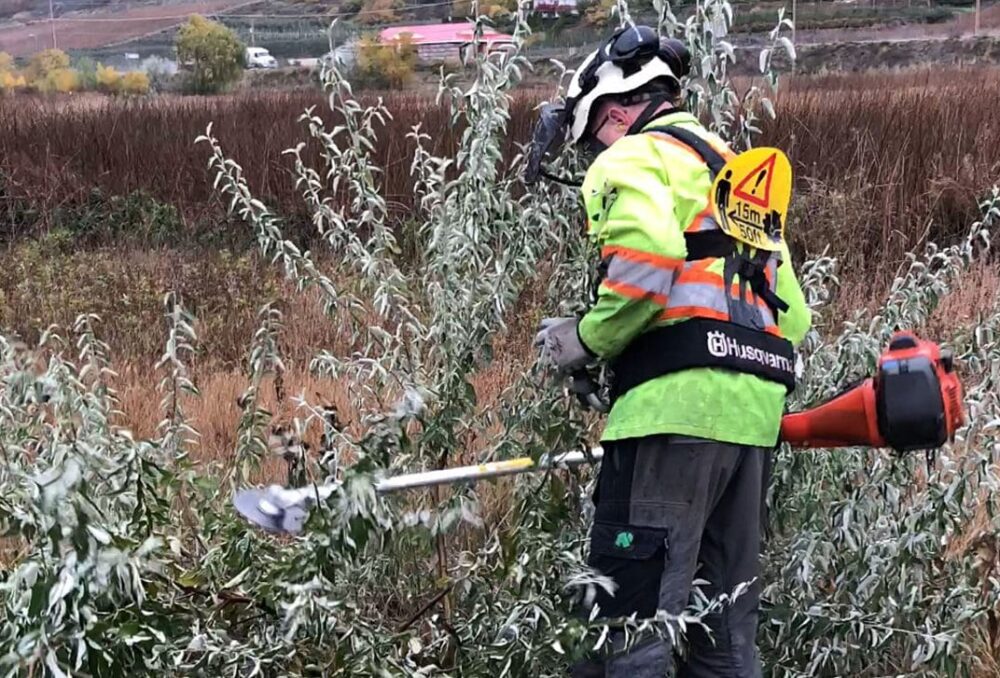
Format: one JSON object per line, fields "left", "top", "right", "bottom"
{"left": 0, "top": 90, "right": 534, "bottom": 231}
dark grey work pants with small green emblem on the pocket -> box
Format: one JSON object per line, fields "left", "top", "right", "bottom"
{"left": 571, "top": 436, "right": 769, "bottom": 678}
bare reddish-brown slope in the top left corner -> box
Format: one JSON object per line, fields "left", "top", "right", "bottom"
{"left": 0, "top": 0, "right": 253, "bottom": 56}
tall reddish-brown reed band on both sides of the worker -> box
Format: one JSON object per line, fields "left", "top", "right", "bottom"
{"left": 0, "top": 69, "right": 1000, "bottom": 266}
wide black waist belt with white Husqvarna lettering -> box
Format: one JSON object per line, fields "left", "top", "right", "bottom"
{"left": 611, "top": 318, "right": 795, "bottom": 400}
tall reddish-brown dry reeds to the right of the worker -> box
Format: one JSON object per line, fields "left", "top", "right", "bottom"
{"left": 763, "top": 69, "right": 1000, "bottom": 270}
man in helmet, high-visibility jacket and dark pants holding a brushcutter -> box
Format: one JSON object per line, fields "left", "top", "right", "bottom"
{"left": 529, "top": 26, "right": 810, "bottom": 678}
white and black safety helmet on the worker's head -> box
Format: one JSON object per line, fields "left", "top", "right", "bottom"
{"left": 565, "top": 26, "right": 690, "bottom": 144}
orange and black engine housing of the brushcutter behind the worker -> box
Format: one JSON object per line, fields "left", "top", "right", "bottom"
{"left": 781, "top": 332, "right": 965, "bottom": 451}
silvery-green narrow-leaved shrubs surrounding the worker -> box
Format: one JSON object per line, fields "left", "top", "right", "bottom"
{"left": 0, "top": 0, "right": 1000, "bottom": 677}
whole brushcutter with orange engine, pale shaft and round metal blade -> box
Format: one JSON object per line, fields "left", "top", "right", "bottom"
{"left": 233, "top": 332, "right": 965, "bottom": 533}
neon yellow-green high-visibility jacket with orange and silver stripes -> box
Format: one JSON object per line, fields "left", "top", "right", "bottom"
{"left": 579, "top": 112, "right": 811, "bottom": 447}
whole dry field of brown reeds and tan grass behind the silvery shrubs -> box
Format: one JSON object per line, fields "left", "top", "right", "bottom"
{"left": 0, "top": 69, "right": 1000, "bottom": 474}
